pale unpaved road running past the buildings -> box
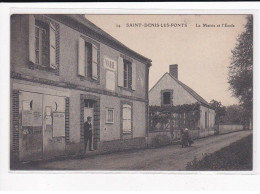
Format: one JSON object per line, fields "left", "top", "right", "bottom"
{"left": 20, "top": 131, "right": 252, "bottom": 171}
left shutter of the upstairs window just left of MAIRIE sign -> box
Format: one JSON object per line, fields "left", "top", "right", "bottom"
{"left": 78, "top": 37, "right": 86, "bottom": 76}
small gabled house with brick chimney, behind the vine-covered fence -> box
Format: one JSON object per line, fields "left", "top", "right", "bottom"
{"left": 149, "top": 64, "right": 215, "bottom": 137}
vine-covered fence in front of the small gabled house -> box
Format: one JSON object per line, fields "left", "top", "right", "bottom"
{"left": 148, "top": 105, "right": 200, "bottom": 145}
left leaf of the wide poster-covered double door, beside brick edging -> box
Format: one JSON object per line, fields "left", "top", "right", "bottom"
{"left": 19, "top": 92, "right": 43, "bottom": 161}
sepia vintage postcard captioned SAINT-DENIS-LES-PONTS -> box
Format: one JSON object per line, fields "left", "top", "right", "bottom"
{"left": 10, "top": 14, "right": 254, "bottom": 172}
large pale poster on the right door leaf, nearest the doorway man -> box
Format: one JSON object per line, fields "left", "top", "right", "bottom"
{"left": 52, "top": 112, "right": 65, "bottom": 137}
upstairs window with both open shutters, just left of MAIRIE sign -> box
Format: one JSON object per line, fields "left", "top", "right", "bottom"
{"left": 78, "top": 37, "right": 98, "bottom": 80}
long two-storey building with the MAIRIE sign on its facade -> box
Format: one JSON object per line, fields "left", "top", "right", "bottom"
{"left": 10, "top": 14, "right": 151, "bottom": 161}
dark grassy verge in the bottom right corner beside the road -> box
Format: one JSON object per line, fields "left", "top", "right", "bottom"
{"left": 186, "top": 135, "right": 253, "bottom": 171}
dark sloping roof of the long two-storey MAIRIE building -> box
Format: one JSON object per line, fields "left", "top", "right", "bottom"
{"left": 68, "top": 14, "right": 152, "bottom": 63}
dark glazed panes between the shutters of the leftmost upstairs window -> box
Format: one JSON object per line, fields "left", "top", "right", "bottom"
{"left": 35, "top": 20, "right": 49, "bottom": 67}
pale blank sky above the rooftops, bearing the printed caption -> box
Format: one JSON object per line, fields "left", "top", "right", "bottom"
{"left": 85, "top": 15, "right": 246, "bottom": 106}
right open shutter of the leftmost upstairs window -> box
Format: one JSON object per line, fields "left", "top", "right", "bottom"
{"left": 49, "top": 23, "right": 57, "bottom": 69}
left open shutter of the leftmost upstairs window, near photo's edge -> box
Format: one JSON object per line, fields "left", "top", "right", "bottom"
{"left": 29, "top": 15, "right": 35, "bottom": 64}
